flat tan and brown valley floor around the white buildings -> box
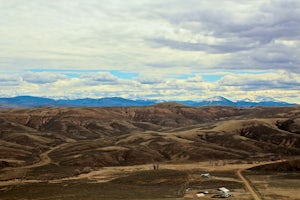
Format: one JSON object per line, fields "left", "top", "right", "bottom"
{"left": 0, "top": 161, "right": 300, "bottom": 200}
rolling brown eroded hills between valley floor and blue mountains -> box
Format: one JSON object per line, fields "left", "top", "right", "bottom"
{"left": 0, "top": 106, "right": 300, "bottom": 179}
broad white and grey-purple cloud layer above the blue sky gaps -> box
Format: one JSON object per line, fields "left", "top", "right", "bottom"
{"left": 0, "top": 0, "right": 300, "bottom": 73}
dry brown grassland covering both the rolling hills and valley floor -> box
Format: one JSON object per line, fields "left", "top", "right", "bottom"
{"left": 0, "top": 104, "right": 300, "bottom": 199}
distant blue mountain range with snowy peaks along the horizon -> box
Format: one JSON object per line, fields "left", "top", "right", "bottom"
{"left": 0, "top": 96, "right": 296, "bottom": 108}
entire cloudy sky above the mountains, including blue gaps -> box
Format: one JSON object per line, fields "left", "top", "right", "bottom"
{"left": 0, "top": 0, "right": 300, "bottom": 103}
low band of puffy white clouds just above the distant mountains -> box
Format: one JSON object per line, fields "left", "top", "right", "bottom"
{"left": 0, "top": 71, "right": 300, "bottom": 102}
